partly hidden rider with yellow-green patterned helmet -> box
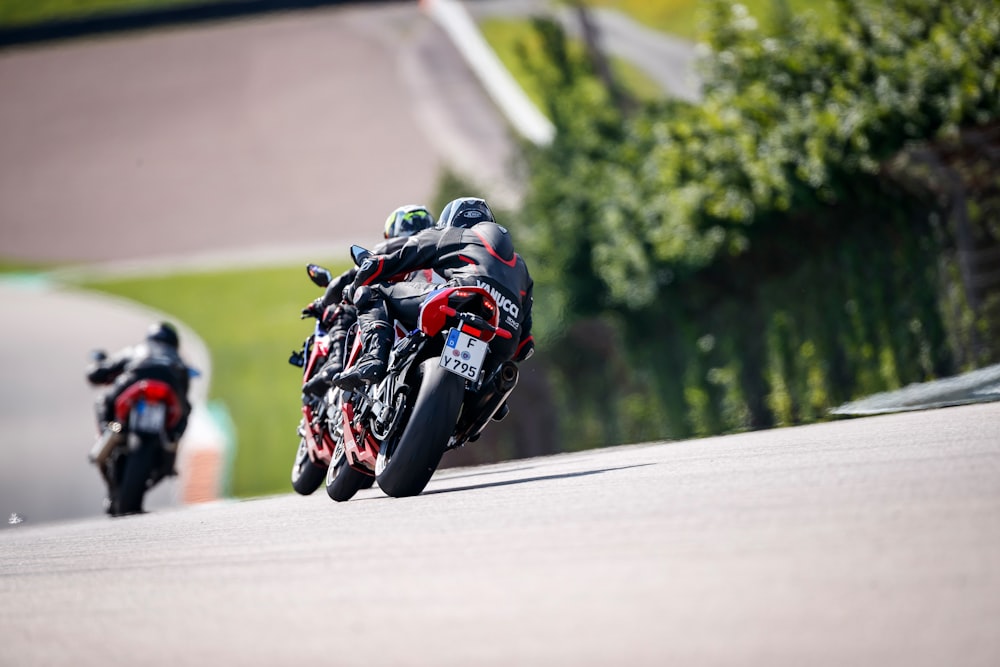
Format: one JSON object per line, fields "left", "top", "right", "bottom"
{"left": 302, "top": 204, "right": 434, "bottom": 396}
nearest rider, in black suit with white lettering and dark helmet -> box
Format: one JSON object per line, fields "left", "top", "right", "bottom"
{"left": 333, "top": 197, "right": 534, "bottom": 389}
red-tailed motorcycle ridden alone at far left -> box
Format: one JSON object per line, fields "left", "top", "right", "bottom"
{"left": 88, "top": 350, "right": 198, "bottom": 516}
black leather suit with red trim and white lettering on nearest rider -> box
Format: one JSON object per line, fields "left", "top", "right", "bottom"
{"left": 354, "top": 222, "right": 534, "bottom": 361}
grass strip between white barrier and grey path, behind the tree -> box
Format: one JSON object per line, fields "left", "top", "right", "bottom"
{"left": 479, "top": 19, "right": 663, "bottom": 109}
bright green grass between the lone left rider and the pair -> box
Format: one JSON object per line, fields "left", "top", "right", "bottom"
{"left": 75, "top": 263, "right": 347, "bottom": 497}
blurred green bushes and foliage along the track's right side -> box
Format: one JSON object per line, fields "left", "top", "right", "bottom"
{"left": 519, "top": 0, "right": 1000, "bottom": 448}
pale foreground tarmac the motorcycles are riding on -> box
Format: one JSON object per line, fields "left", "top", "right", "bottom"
{"left": 0, "top": 403, "right": 1000, "bottom": 667}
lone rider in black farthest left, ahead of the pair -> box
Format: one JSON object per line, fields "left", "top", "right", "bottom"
{"left": 87, "top": 322, "right": 191, "bottom": 476}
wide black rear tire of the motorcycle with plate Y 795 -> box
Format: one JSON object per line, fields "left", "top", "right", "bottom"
{"left": 376, "top": 358, "right": 465, "bottom": 498}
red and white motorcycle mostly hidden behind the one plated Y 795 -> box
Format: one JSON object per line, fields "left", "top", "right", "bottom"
{"left": 288, "top": 264, "right": 374, "bottom": 496}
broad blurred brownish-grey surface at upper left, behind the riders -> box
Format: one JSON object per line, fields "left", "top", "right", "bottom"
{"left": 0, "top": 2, "right": 510, "bottom": 263}
